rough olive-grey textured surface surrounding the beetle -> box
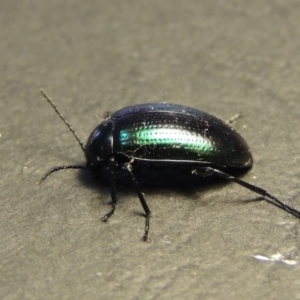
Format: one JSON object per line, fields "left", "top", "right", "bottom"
{"left": 0, "top": 0, "right": 300, "bottom": 300}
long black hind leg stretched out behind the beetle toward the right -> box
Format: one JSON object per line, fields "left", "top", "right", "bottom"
{"left": 205, "top": 167, "right": 300, "bottom": 219}
